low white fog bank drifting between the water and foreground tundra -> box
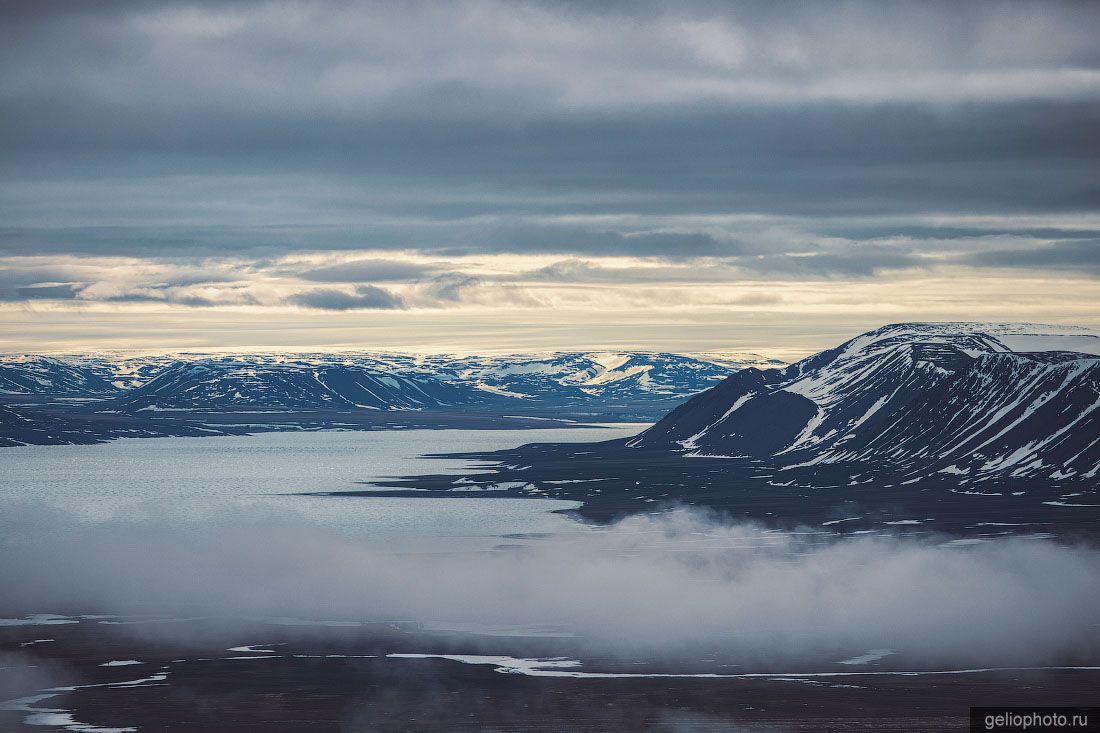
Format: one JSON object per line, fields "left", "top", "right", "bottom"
{"left": 0, "top": 503, "right": 1100, "bottom": 667}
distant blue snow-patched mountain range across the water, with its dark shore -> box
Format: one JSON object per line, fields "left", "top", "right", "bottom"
{"left": 0, "top": 352, "right": 782, "bottom": 445}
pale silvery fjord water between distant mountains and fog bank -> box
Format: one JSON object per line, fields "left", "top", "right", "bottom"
{"left": 0, "top": 424, "right": 646, "bottom": 549}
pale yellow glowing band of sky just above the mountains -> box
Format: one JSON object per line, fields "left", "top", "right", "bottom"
{"left": 0, "top": 246, "right": 1100, "bottom": 359}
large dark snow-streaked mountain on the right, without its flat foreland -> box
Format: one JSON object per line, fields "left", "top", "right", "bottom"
{"left": 627, "top": 324, "right": 1100, "bottom": 484}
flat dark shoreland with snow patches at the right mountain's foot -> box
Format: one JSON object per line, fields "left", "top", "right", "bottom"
{"left": 323, "top": 433, "right": 1100, "bottom": 541}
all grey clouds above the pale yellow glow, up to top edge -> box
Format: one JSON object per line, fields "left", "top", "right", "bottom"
{"left": 0, "top": 0, "right": 1100, "bottom": 283}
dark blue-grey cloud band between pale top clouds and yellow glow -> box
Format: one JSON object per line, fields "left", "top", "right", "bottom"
{"left": 0, "top": 106, "right": 1100, "bottom": 263}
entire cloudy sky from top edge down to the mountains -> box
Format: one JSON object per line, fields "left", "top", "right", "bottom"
{"left": 0, "top": 0, "right": 1100, "bottom": 358}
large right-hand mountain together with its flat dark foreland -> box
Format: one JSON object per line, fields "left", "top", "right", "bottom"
{"left": 372, "top": 324, "right": 1100, "bottom": 540}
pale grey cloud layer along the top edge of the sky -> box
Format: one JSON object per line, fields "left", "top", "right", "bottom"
{"left": 2, "top": 0, "right": 1100, "bottom": 130}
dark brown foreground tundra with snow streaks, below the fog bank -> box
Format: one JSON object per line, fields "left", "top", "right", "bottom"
{"left": 0, "top": 619, "right": 1100, "bottom": 733}
